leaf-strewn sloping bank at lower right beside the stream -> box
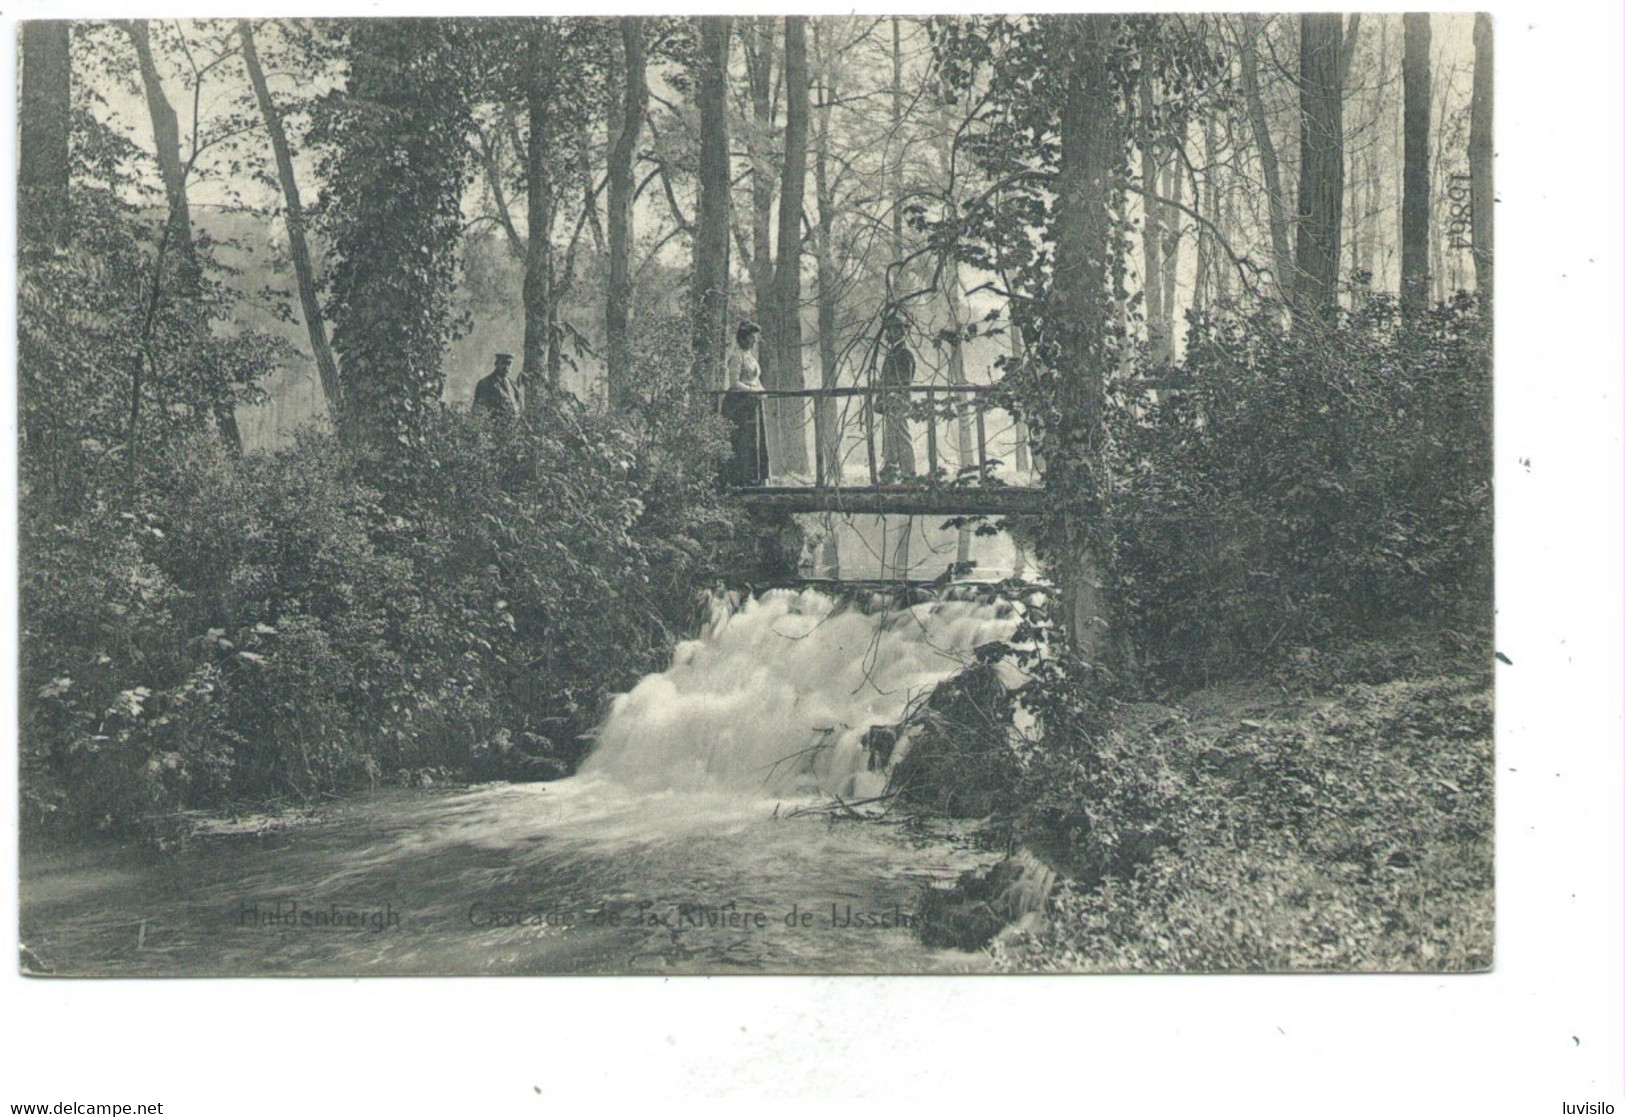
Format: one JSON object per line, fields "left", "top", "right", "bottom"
{"left": 995, "top": 631, "right": 1495, "bottom": 972}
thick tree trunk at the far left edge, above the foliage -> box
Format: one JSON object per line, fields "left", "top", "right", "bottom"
{"left": 18, "top": 20, "right": 73, "bottom": 255}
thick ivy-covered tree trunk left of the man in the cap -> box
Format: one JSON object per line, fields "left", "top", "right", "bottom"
{"left": 322, "top": 20, "right": 473, "bottom": 449}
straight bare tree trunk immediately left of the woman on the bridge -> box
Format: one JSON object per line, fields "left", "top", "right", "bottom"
{"left": 692, "top": 16, "right": 733, "bottom": 392}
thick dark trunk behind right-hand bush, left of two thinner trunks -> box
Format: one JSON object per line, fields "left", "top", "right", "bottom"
{"left": 1292, "top": 15, "right": 1342, "bottom": 325}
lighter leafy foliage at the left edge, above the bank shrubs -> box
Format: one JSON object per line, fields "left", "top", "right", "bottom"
{"left": 18, "top": 102, "right": 286, "bottom": 507}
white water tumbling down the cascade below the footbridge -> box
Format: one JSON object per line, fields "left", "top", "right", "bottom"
{"left": 582, "top": 589, "right": 1017, "bottom": 797}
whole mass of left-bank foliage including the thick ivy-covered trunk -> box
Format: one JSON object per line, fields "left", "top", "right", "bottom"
{"left": 20, "top": 21, "right": 770, "bottom": 834}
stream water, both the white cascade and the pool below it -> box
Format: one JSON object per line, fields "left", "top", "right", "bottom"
{"left": 21, "top": 590, "right": 1016, "bottom": 976}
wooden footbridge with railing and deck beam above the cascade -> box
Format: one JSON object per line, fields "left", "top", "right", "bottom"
{"left": 718, "top": 384, "right": 1047, "bottom": 515}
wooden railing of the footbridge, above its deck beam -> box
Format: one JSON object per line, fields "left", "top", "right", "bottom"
{"left": 715, "top": 384, "right": 1042, "bottom": 489}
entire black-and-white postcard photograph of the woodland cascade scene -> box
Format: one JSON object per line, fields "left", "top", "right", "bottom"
{"left": 0, "top": 5, "right": 1620, "bottom": 1112}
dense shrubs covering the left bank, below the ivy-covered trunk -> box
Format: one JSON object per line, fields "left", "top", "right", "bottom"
{"left": 23, "top": 388, "right": 730, "bottom": 845}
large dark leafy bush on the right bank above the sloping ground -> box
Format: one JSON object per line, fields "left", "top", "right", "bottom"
{"left": 1110, "top": 296, "right": 1492, "bottom": 681}
